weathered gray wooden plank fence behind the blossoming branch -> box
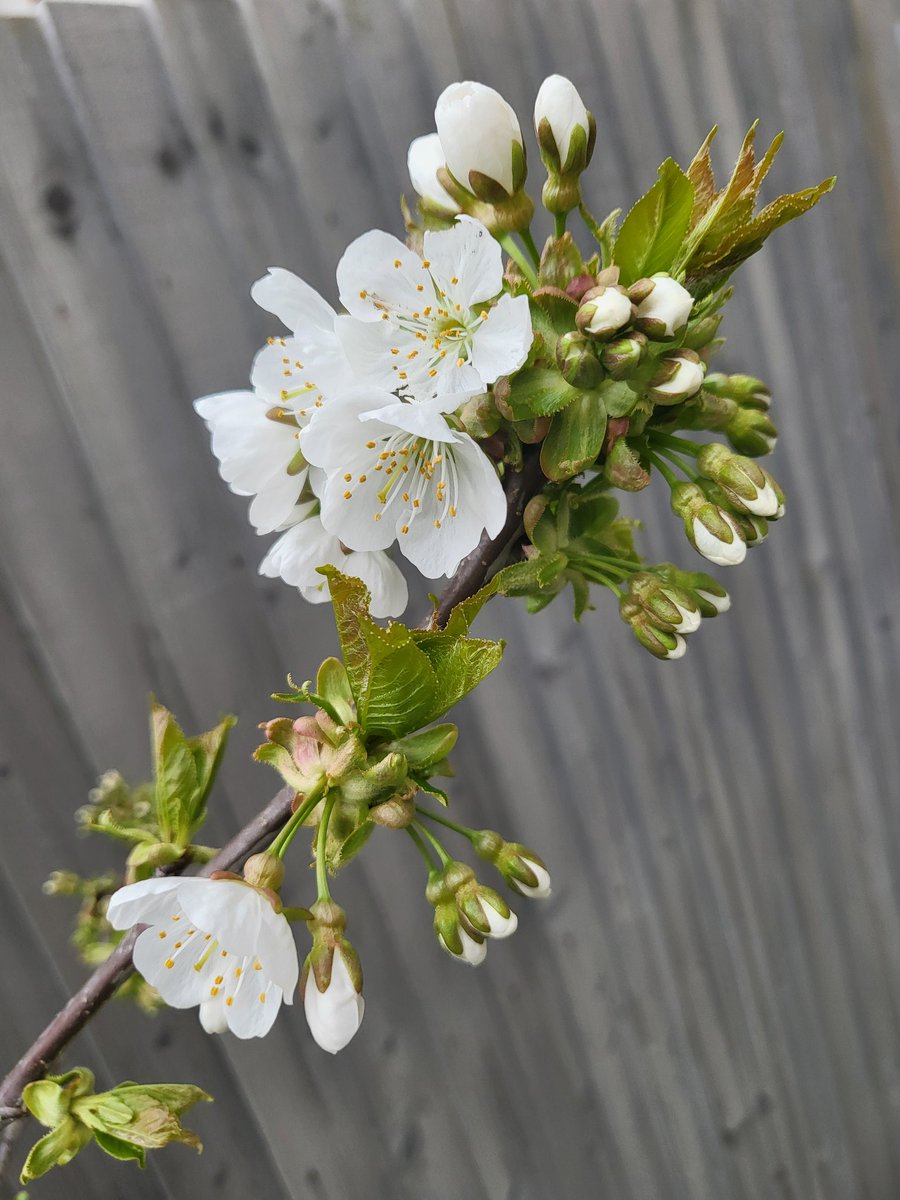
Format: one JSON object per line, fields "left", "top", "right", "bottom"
{"left": 0, "top": 0, "right": 900, "bottom": 1200}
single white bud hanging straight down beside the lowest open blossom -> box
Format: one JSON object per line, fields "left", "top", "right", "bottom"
{"left": 300, "top": 900, "right": 366, "bottom": 1054}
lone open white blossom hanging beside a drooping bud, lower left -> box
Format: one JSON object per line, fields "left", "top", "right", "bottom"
{"left": 107, "top": 877, "right": 300, "bottom": 1038}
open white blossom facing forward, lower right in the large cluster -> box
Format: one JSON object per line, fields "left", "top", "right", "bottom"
{"left": 301, "top": 389, "right": 506, "bottom": 578}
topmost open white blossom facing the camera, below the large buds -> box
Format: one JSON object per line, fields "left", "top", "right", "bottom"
{"left": 337, "top": 216, "right": 533, "bottom": 396}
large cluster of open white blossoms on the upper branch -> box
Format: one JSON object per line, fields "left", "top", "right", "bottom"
{"left": 194, "top": 127, "right": 532, "bottom": 617}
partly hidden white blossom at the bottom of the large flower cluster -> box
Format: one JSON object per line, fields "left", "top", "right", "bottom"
{"left": 259, "top": 500, "right": 408, "bottom": 617}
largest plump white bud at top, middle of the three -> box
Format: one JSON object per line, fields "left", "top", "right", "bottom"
{"left": 434, "top": 80, "right": 526, "bottom": 204}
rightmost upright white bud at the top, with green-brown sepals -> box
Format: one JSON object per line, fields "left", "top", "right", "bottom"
{"left": 534, "top": 74, "right": 596, "bottom": 214}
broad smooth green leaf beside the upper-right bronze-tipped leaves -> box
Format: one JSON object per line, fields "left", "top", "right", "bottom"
{"left": 612, "top": 158, "right": 694, "bottom": 287}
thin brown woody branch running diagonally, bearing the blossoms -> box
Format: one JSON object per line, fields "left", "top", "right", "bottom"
{"left": 0, "top": 454, "right": 542, "bottom": 1176}
